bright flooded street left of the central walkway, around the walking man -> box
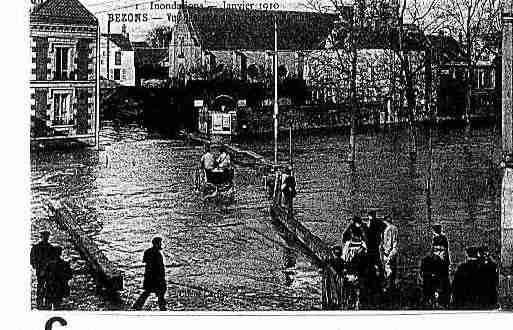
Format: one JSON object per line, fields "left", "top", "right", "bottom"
{"left": 32, "top": 122, "right": 320, "bottom": 310}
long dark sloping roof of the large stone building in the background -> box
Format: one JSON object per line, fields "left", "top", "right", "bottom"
{"left": 183, "top": 7, "right": 337, "bottom": 50}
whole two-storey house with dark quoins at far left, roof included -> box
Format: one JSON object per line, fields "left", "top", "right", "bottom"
{"left": 30, "top": 0, "right": 98, "bottom": 139}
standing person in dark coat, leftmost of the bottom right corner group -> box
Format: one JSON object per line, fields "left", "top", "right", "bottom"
{"left": 420, "top": 243, "right": 450, "bottom": 308}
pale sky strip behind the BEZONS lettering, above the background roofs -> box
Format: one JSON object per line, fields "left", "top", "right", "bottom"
{"left": 80, "top": 0, "right": 302, "bottom": 41}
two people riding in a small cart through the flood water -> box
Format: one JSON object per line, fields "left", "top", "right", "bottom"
{"left": 200, "top": 144, "right": 233, "bottom": 185}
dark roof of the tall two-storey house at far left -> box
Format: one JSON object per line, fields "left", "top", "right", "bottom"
{"left": 30, "top": 0, "right": 98, "bottom": 25}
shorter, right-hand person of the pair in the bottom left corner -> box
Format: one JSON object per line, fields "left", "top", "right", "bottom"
{"left": 44, "top": 246, "right": 73, "bottom": 310}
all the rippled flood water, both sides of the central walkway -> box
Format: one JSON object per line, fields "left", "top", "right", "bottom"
{"left": 31, "top": 124, "right": 500, "bottom": 310}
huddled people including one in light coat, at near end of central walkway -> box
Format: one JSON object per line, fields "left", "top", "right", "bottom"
{"left": 328, "top": 211, "right": 398, "bottom": 308}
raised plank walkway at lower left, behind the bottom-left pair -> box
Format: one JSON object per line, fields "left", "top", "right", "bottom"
{"left": 44, "top": 200, "right": 123, "bottom": 293}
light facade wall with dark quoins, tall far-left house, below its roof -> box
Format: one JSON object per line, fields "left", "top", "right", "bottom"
{"left": 30, "top": 24, "right": 97, "bottom": 138}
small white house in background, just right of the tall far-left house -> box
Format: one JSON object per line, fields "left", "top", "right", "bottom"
{"left": 100, "top": 25, "right": 136, "bottom": 86}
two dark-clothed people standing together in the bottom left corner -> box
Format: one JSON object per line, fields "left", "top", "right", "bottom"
{"left": 30, "top": 231, "right": 73, "bottom": 310}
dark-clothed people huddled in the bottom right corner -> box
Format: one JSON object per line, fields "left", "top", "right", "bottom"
{"left": 421, "top": 223, "right": 498, "bottom": 309}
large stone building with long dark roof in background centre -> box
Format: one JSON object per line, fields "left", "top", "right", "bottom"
{"left": 169, "top": 7, "right": 336, "bottom": 82}
